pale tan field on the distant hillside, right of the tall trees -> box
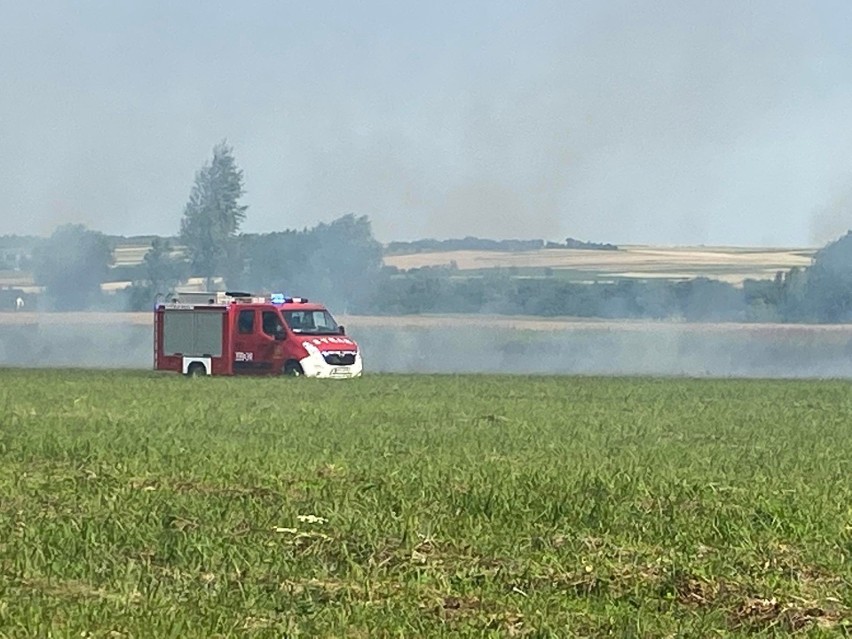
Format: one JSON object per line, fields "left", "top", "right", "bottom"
{"left": 385, "top": 246, "right": 815, "bottom": 284}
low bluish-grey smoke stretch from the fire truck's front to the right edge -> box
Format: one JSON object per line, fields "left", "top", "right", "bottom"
{"left": 353, "top": 322, "right": 852, "bottom": 378}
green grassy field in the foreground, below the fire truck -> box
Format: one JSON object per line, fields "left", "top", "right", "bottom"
{"left": 0, "top": 370, "right": 852, "bottom": 638}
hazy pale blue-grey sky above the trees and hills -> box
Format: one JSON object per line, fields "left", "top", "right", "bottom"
{"left": 0, "top": 0, "right": 852, "bottom": 245}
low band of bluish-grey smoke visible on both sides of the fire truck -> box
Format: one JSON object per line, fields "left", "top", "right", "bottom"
{"left": 0, "top": 315, "right": 852, "bottom": 378}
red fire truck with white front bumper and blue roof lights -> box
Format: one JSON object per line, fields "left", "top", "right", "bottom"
{"left": 154, "top": 292, "right": 363, "bottom": 378}
